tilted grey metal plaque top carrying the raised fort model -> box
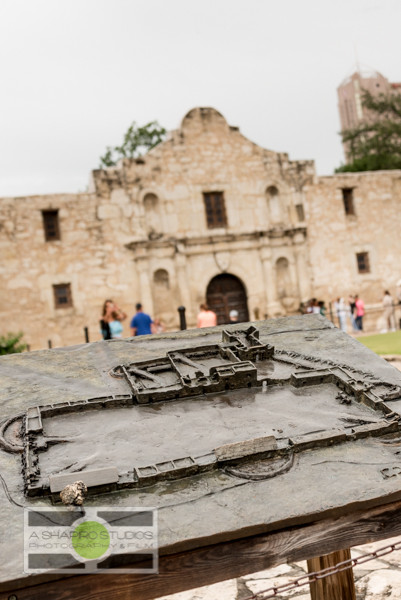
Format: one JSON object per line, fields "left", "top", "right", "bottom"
{"left": 0, "top": 316, "right": 401, "bottom": 592}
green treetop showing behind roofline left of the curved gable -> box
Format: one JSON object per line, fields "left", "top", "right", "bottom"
{"left": 100, "top": 121, "right": 166, "bottom": 168}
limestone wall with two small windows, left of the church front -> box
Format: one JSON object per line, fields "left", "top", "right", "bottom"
{"left": 0, "top": 194, "right": 136, "bottom": 349}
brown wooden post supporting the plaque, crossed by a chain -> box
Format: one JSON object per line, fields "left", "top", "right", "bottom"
{"left": 307, "top": 549, "right": 356, "bottom": 600}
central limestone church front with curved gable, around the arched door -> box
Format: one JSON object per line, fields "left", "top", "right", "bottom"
{"left": 93, "top": 108, "right": 314, "bottom": 327}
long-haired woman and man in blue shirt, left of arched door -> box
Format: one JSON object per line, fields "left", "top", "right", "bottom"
{"left": 100, "top": 300, "right": 164, "bottom": 340}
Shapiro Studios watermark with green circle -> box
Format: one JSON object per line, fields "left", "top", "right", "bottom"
{"left": 24, "top": 506, "right": 158, "bottom": 574}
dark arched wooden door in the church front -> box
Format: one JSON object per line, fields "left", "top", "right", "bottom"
{"left": 206, "top": 273, "right": 249, "bottom": 325}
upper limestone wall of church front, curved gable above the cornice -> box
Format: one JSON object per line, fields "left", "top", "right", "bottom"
{"left": 94, "top": 109, "right": 314, "bottom": 241}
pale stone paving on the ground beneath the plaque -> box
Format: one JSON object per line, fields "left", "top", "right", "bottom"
{"left": 157, "top": 356, "right": 401, "bottom": 600}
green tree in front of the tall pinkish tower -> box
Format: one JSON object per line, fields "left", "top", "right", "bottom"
{"left": 336, "top": 90, "right": 401, "bottom": 173}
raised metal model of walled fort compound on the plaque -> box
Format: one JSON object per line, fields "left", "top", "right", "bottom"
{"left": 0, "top": 327, "right": 401, "bottom": 499}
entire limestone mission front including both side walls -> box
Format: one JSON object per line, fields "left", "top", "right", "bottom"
{"left": 0, "top": 108, "right": 401, "bottom": 349}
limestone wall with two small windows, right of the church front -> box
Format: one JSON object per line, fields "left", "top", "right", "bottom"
{"left": 307, "top": 171, "right": 401, "bottom": 304}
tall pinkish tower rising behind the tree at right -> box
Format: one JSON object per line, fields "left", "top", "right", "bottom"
{"left": 337, "top": 69, "right": 401, "bottom": 159}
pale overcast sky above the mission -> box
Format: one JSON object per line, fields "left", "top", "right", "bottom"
{"left": 0, "top": 0, "right": 401, "bottom": 196}
